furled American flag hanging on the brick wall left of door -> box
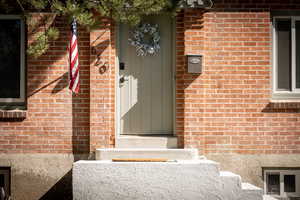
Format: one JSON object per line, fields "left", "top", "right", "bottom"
{"left": 69, "top": 19, "right": 80, "bottom": 93}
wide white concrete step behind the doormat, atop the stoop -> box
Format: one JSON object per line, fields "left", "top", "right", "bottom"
{"left": 96, "top": 148, "right": 199, "bottom": 160}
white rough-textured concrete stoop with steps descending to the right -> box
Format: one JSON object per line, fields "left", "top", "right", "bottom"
{"left": 73, "top": 149, "right": 263, "bottom": 200}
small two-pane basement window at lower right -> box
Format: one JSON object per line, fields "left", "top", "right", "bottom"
{"left": 264, "top": 169, "right": 300, "bottom": 200}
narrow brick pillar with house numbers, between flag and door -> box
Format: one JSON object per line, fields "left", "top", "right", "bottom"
{"left": 90, "top": 19, "right": 116, "bottom": 150}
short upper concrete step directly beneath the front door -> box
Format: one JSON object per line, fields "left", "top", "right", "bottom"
{"left": 116, "top": 135, "right": 177, "bottom": 149}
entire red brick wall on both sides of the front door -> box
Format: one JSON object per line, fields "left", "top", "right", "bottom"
{"left": 0, "top": 0, "right": 300, "bottom": 154}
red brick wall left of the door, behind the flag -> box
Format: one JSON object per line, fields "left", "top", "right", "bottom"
{"left": 0, "top": 14, "right": 114, "bottom": 153}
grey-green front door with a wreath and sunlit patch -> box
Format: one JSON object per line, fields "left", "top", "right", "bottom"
{"left": 118, "top": 16, "right": 174, "bottom": 135}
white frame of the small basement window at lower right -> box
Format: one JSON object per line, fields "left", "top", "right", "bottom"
{"left": 264, "top": 170, "right": 300, "bottom": 198}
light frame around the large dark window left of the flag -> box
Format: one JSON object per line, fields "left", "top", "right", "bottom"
{"left": 0, "top": 15, "right": 25, "bottom": 103}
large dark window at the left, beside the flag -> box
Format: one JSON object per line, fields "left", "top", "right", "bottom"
{"left": 0, "top": 15, "right": 25, "bottom": 103}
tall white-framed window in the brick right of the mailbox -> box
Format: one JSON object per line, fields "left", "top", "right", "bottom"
{"left": 273, "top": 16, "right": 300, "bottom": 98}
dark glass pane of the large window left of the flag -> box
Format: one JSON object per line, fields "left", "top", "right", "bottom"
{"left": 0, "top": 19, "right": 21, "bottom": 98}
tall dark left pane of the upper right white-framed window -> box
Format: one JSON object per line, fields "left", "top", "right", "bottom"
{"left": 275, "top": 19, "right": 291, "bottom": 90}
